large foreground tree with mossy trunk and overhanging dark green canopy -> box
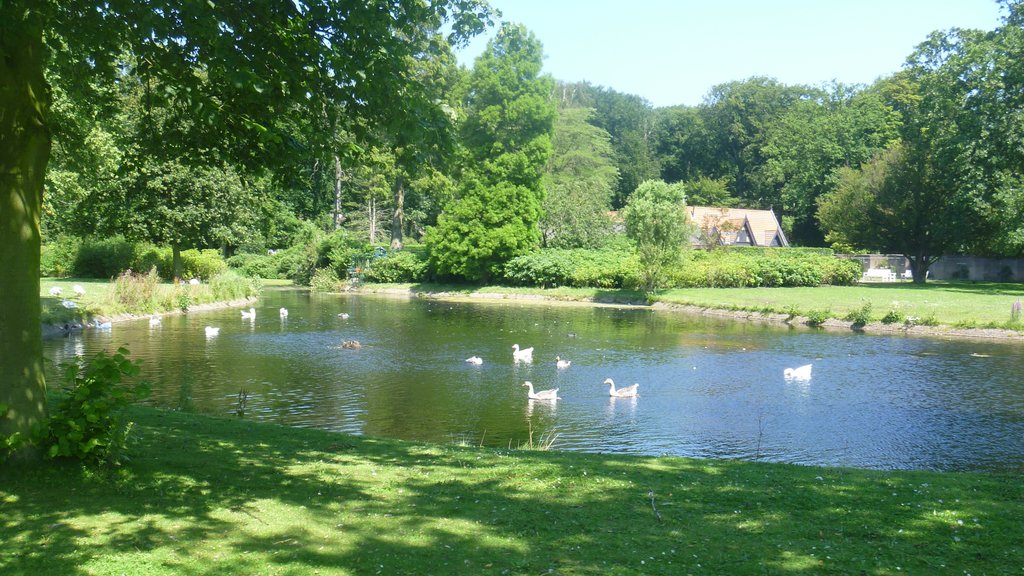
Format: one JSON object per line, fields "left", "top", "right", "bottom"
{"left": 0, "top": 0, "right": 488, "bottom": 444}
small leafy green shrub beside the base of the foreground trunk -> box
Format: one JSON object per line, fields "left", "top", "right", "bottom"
{"left": 42, "top": 347, "right": 150, "bottom": 464}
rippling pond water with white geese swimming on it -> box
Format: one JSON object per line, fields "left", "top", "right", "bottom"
{"left": 44, "top": 289, "right": 1024, "bottom": 470}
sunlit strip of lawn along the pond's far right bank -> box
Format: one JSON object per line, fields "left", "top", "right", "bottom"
{"left": 361, "top": 282, "right": 1024, "bottom": 331}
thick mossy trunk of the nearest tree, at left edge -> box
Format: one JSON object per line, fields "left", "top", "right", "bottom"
{"left": 0, "top": 12, "right": 50, "bottom": 444}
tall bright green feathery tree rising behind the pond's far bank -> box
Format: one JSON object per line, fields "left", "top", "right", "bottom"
{"left": 426, "top": 24, "right": 555, "bottom": 281}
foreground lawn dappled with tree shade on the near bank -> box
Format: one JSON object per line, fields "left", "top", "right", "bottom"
{"left": 0, "top": 409, "right": 1024, "bottom": 576}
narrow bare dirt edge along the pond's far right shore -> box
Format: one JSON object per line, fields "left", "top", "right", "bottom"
{"left": 350, "top": 287, "right": 1024, "bottom": 341}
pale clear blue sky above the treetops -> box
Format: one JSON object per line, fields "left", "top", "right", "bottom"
{"left": 458, "top": 0, "right": 1001, "bottom": 107}
